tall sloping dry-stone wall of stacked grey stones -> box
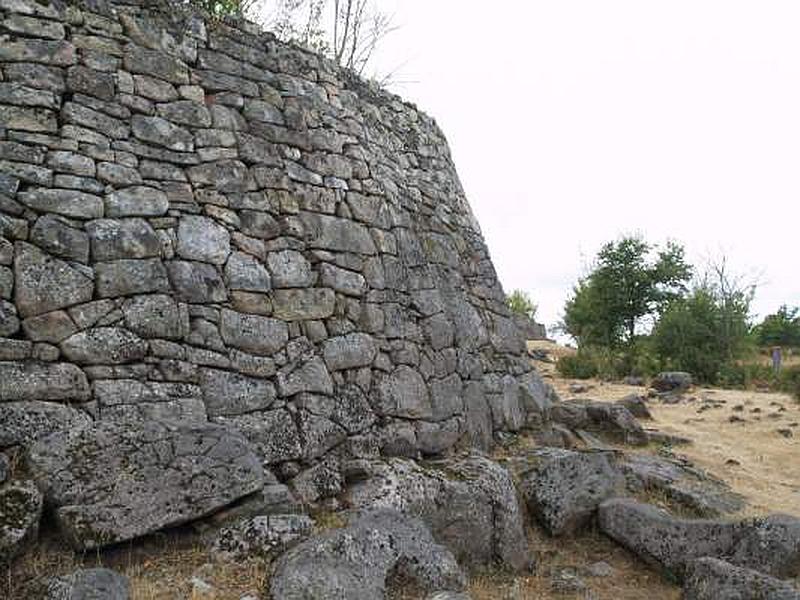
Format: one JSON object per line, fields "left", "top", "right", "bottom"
{"left": 0, "top": 0, "right": 549, "bottom": 494}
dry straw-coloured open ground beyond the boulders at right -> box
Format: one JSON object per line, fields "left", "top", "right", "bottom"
{"left": 531, "top": 342, "right": 800, "bottom": 516}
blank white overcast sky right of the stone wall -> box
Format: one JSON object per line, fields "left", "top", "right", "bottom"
{"left": 358, "top": 0, "right": 800, "bottom": 332}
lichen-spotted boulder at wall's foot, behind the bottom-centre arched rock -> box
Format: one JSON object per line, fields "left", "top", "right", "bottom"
{"left": 345, "top": 454, "right": 532, "bottom": 571}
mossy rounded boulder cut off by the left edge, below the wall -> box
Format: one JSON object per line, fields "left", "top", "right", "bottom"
{"left": 0, "top": 481, "right": 42, "bottom": 564}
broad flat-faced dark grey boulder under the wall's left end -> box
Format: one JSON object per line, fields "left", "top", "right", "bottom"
{"left": 27, "top": 421, "right": 263, "bottom": 550}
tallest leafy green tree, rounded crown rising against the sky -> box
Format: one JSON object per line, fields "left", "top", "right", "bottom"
{"left": 564, "top": 237, "right": 692, "bottom": 358}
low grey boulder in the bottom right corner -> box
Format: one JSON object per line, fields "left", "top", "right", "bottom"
{"left": 682, "top": 558, "right": 800, "bottom": 600}
